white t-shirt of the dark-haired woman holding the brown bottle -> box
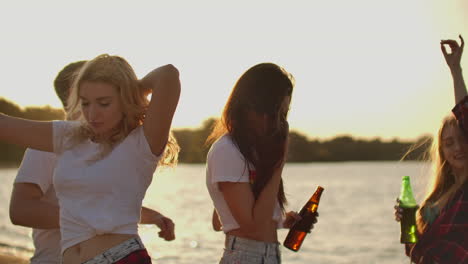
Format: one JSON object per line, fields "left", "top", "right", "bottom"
{"left": 206, "top": 134, "right": 283, "bottom": 233}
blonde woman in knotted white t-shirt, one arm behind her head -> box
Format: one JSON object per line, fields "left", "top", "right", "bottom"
{"left": 0, "top": 55, "right": 180, "bottom": 264}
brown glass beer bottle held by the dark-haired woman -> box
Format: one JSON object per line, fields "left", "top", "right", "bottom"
{"left": 283, "top": 186, "right": 323, "bottom": 251}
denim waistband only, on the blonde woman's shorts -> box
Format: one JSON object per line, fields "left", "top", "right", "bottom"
{"left": 83, "top": 237, "right": 145, "bottom": 264}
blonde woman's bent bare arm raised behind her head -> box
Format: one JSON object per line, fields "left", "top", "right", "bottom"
{"left": 141, "top": 64, "right": 180, "bottom": 155}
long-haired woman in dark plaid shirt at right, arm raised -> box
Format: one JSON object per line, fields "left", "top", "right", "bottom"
{"left": 395, "top": 36, "right": 468, "bottom": 263}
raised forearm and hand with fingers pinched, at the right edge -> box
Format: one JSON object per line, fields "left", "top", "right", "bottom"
{"left": 440, "top": 35, "right": 467, "bottom": 104}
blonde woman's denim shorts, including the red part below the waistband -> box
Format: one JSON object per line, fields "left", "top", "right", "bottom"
{"left": 83, "top": 237, "right": 151, "bottom": 264}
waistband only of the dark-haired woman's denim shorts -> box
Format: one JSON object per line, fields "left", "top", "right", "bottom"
{"left": 224, "top": 235, "right": 280, "bottom": 256}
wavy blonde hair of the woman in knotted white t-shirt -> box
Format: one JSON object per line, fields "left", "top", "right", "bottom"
{"left": 67, "top": 54, "right": 180, "bottom": 166}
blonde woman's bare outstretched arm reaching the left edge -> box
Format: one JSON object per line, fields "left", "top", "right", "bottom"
{"left": 0, "top": 113, "right": 53, "bottom": 152}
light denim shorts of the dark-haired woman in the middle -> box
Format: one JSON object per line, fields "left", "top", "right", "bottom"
{"left": 219, "top": 235, "right": 281, "bottom": 264}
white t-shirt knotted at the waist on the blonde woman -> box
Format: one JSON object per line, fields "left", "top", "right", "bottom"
{"left": 53, "top": 121, "right": 160, "bottom": 253}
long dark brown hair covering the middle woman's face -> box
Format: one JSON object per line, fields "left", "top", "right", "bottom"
{"left": 207, "top": 63, "right": 294, "bottom": 211}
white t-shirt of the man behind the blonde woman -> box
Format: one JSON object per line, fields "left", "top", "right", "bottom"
{"left": 15, "top": 149, "right": 61, "bottom": 264}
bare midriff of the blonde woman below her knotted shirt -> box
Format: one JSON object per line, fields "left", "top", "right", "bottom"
{"left": 63, "top": 234, "right": 137, "bottom": 264}
